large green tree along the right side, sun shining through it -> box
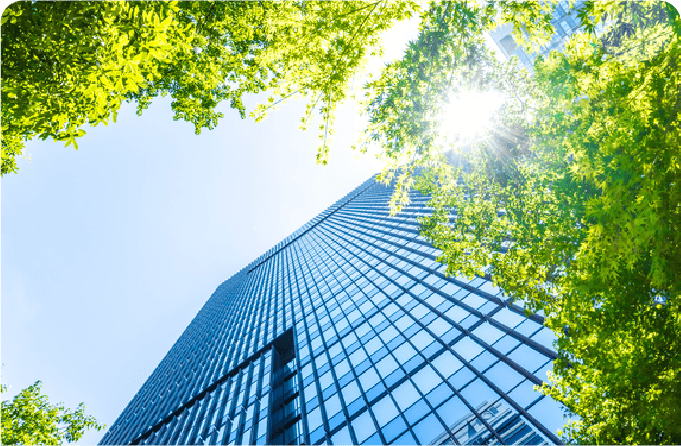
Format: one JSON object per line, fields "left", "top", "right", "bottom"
{"left": 358, "top": 1, "right": 681, "bottom": 445}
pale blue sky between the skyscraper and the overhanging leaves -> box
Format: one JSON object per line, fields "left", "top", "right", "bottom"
{"left": 0, "top": 21, "right": 416, "bottom": 445}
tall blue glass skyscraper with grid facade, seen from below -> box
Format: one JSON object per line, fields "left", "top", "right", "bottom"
{"left": 100, "top": 179, "right": 563, "bottom": 446}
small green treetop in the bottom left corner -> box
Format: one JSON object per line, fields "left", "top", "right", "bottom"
{"left": 0, "top": 381, "right": 106, "bottom": 446}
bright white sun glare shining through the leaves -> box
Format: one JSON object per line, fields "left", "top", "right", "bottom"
{"left": 441, "top": 91, "right": 504, "bottom": 142}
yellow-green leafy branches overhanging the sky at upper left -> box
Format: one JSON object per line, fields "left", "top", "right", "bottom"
{"left": 0, "top": 0, "right": 418, "bottom": 175}
